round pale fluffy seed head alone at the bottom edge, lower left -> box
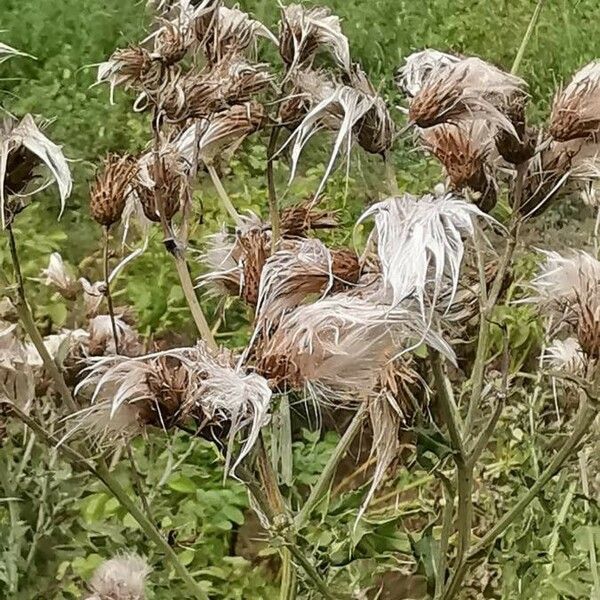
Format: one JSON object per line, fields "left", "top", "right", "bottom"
{"left": 87, "top": 554, "right": 152, "bottom": 600}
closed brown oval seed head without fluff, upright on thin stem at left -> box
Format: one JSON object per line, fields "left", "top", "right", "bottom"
{"left": 90, "top": 154, "right": 138, "bottom": 227}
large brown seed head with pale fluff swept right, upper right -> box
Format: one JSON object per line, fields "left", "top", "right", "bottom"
{"left": 408, "top": 58, "right": 526, "bottom": 137}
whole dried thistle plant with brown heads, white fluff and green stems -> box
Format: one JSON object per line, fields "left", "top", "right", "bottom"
{"left": 0, "top": 0, "right": 600, "bottom": 600}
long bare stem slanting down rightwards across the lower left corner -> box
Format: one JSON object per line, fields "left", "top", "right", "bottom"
{"left": 11, "top": 404, "right": 208, "bottom": 600}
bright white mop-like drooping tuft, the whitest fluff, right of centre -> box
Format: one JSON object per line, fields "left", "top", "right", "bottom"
{"left": 358, "top": 194, "right": 495, "bottom": 310}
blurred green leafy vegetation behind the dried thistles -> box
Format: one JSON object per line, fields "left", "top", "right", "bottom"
{"left": 0, "top": 0, "right": 600, "bottom": 600}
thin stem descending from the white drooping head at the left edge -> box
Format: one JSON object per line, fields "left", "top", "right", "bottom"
{"left": 6, "top": 225, "right": 77, "bottom": 412}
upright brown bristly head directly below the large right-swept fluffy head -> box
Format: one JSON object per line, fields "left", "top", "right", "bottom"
{"left": 422, "top": 121, "right": 497, "bottom": 212}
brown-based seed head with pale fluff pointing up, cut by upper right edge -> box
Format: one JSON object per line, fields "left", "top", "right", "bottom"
{"left": 550, "top": 61, "right": 600, "bottom": 142}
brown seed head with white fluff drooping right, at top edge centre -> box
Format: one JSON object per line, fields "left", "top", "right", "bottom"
{"left": 279, "top": 4, "right": 351, "bottom": 71}
